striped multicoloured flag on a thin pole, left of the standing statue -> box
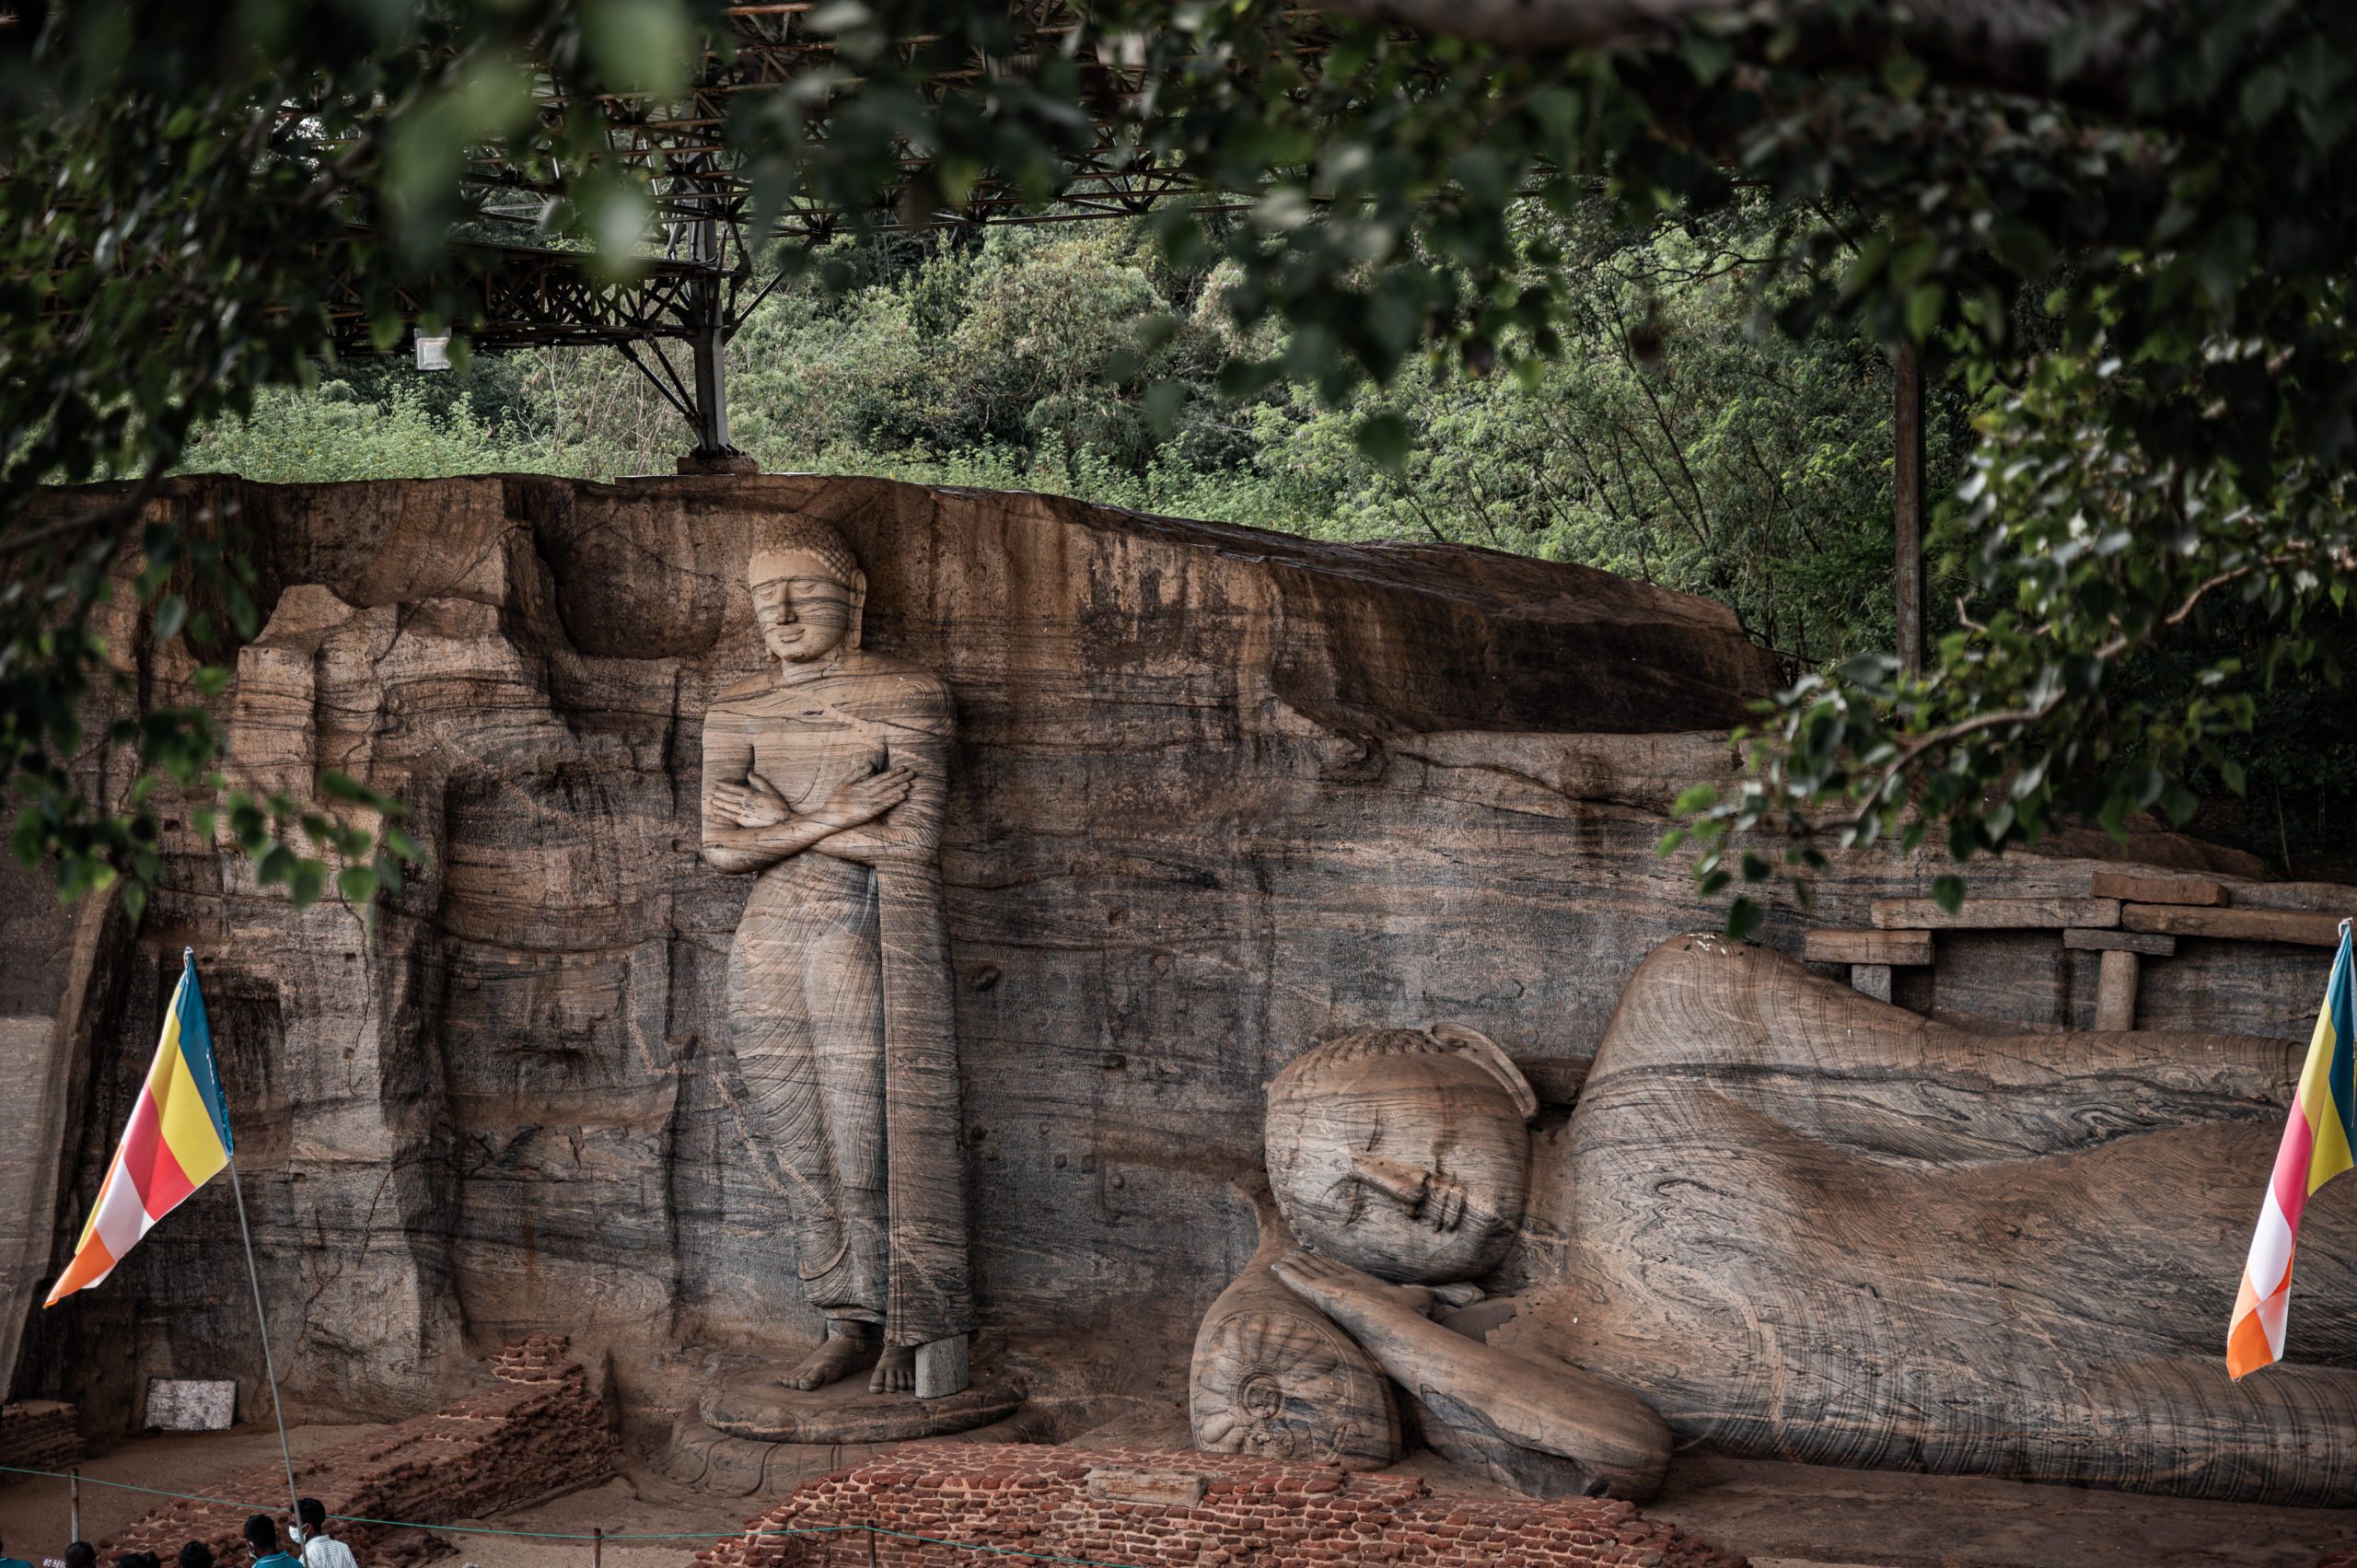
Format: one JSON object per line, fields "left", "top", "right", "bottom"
{"left": 42, "top": 947, "right": 233, "bottom": 1307}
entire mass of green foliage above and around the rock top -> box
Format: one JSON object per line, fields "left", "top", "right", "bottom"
{"left": 0, "top": 0, "right": 2357, "bottom": 932}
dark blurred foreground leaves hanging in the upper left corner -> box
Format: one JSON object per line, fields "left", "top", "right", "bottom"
{"left": 0, "top": 0, "right": 710, "bottom": 912}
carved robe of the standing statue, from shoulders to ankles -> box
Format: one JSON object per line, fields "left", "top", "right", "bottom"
{"left": 704, "top": 653, "right": 973, "bottom": 1344}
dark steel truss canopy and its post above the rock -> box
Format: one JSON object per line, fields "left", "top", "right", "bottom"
{"left": 379, "top": 0, "right": 1200, "bottom": 462}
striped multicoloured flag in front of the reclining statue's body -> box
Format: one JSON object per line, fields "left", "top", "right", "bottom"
{"left": 2225, "top": 920, "right": 2357, "bottom": 1377}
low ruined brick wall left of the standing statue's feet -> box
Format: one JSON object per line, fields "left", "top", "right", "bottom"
{"left": 101, "top": 1334, "right": 618, "bottom": 1568}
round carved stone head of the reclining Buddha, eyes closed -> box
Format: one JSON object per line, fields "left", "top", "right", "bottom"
{"left": 1266, "top": 1026, "right": 1539, "bottom": 1285}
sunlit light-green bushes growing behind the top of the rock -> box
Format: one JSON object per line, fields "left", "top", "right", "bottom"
{"left": 189, "top": 201, "right": 1933, "bottom": 668}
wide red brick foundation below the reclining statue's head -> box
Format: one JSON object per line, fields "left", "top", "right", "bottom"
{"left": 695, "top": 1443, "right": 1742, "bottom": 1568}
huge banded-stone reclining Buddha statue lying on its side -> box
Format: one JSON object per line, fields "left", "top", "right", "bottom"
{"left": 1197, "top": 936, "right": 2357, "bottom": 1506}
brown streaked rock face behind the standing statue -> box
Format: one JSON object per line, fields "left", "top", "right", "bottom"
{"left": 0, "top": 476, "right": 2319, "bottom": 1431}
